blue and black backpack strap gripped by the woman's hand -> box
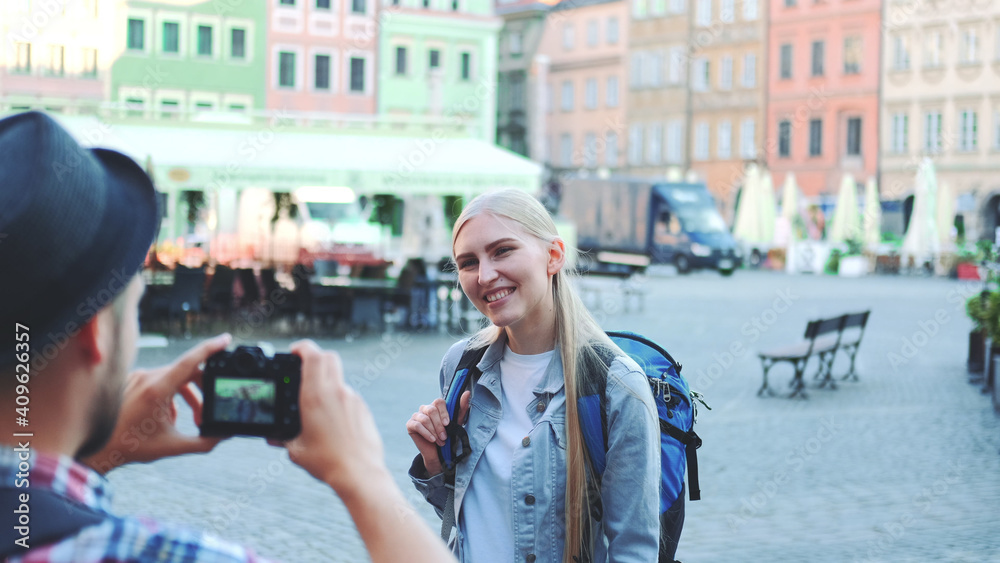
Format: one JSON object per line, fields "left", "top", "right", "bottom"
{"left": 438, "top": 346, "right": 487, "bottom": 543}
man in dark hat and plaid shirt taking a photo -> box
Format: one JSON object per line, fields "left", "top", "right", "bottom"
{"left": 0, "top": 112, "right": 453, "bottom": 562}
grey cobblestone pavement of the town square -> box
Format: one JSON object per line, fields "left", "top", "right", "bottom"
{"left": 110, "top": 271, "right": 1000, "bottom": 563}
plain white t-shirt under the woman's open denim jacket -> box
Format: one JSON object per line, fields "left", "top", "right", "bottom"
{"left": 461, "top": 347, "right": 555, "bottom": 563}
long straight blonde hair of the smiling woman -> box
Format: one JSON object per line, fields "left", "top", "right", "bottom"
{"left": 451, "top": 189, "right": 618, "bottom": 563}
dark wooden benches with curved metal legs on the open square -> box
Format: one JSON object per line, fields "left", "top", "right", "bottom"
{"left": 757, "top": 311, "right": 871, "bottom": 398}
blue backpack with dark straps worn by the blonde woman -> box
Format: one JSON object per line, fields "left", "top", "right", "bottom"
{"left": 438, "top": 332, "right": 711, "bottom": 563}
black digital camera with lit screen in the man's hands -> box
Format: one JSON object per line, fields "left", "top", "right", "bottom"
{"left": 201, "top": 346, "right": 302, "bottom": 440}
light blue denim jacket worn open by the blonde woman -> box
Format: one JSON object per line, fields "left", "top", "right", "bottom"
{"left": 410, "top": 337, "right": 660, "bottom": 563}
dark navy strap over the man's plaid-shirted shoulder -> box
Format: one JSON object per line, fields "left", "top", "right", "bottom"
{"left": 0, "top": 487, "right": 108, "bottom": 559}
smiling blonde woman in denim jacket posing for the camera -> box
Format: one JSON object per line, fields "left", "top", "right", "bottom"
{"left": 406, "top": 190, "right": 660, "bottom": 563}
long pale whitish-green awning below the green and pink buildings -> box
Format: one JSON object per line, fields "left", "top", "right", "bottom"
{"left": 53, "top": 116, "right": 542, "bottom": 195}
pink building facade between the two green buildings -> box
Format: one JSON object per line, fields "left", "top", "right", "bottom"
{"left": 266, "top": 0, "right": 378, "bottom": 114}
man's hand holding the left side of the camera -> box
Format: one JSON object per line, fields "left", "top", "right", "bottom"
{"left": 81, "top": 334, "right": 232, "bottom": 473}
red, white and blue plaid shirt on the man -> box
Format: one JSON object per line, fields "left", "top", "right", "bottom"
{"left": 0, "top": 446, "right": 274, "bottom": 563}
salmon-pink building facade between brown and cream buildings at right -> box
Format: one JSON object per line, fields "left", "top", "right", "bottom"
{"left": 764, "top": 0, "right": 881, "bottom": 197}
